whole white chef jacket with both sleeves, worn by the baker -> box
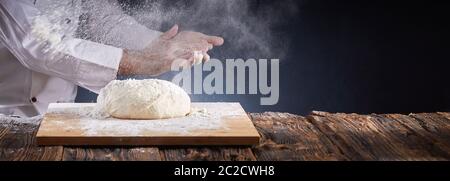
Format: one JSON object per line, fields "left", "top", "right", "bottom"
{"left": 0, "top": 0, "right": 161, "bottom": 117}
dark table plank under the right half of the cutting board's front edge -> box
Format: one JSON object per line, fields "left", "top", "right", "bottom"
{"left": 159, "top": 146, "right": 256, "bottom": 161}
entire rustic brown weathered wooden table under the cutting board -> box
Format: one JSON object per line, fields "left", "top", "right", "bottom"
{"left": 0, "top": 112, "right": 450, "bottom": 161}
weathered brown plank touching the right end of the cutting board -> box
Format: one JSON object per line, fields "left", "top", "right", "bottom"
{"left": 250, "top": 112, "right": 347, "bottom": 161}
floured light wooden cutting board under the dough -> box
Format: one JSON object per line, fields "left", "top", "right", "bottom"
{"left": 36, "top": 103, "right": 260, "bottom": 145}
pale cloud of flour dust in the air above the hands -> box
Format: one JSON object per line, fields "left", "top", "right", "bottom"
{"left": 119, "top": 0, "right": 299, "bottom": 59}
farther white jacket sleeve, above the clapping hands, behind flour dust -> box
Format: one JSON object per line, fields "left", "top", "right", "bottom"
{"left": 83, "top": 0, "right": 162, "bottom": 50}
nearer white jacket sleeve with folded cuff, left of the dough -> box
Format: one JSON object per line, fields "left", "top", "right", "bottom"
{"left": 0, "top": 0, "right": 122, "bottom": 93}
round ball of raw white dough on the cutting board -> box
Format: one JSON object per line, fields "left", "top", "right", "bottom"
{"left": 97, "top": 79, "right": 191, "bottom": 119}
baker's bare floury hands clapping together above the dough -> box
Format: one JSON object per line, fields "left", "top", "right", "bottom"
{"left": 118, "top": 25, "right": 224, "bottom": 76}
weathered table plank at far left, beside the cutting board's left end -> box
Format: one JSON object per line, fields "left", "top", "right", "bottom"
{"left": 0, "top": 121, "right": 62, "bottom": 161}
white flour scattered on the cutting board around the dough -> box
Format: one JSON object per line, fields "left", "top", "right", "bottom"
{"left": 49, "top": 104, "right": 242, "bottom": 136}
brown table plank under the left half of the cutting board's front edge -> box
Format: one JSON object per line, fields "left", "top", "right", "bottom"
{"left": 63, "top": 147, "right": 161, "bottom": 161}
